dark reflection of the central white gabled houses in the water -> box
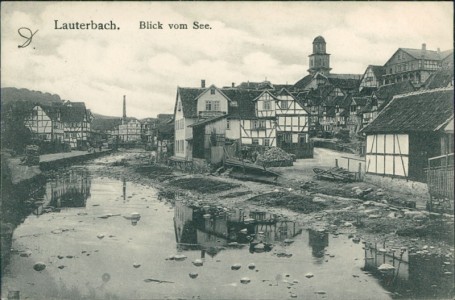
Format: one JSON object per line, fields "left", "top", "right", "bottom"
{"left": 174, "top": 201, "right": 302, "bottom": 258}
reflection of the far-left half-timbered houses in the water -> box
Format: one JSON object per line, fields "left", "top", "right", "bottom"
{"left": 46, "top": 169, "right": 91, "bottom": 208}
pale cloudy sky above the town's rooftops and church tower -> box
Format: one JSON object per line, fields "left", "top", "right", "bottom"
{"left": 1, "top": 1, "right": 454, "bottom": 118}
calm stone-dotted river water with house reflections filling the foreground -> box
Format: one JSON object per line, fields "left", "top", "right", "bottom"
{"left": 2, "top": 158, "right": 453, "bottom": 299}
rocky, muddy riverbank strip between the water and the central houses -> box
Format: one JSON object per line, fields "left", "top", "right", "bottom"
{"left": 105, "top": 154, "right": 454, "bottom": 262}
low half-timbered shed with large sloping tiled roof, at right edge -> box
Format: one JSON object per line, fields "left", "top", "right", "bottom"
{"left": 361, "top": 87, "right": 454, "bottom": 181}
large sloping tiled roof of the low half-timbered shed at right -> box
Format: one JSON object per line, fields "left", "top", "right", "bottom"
{"left": 362, "top": 87, "right": 454, "bottom": 133}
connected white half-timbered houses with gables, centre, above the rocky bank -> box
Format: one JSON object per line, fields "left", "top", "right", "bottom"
{"left": 174, "top": 84, "right": 309, "bottom": 160}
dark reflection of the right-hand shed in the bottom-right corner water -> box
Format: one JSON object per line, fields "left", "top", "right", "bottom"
{"left": 363, "top": 245, "right": 455, "bottom": 299}
